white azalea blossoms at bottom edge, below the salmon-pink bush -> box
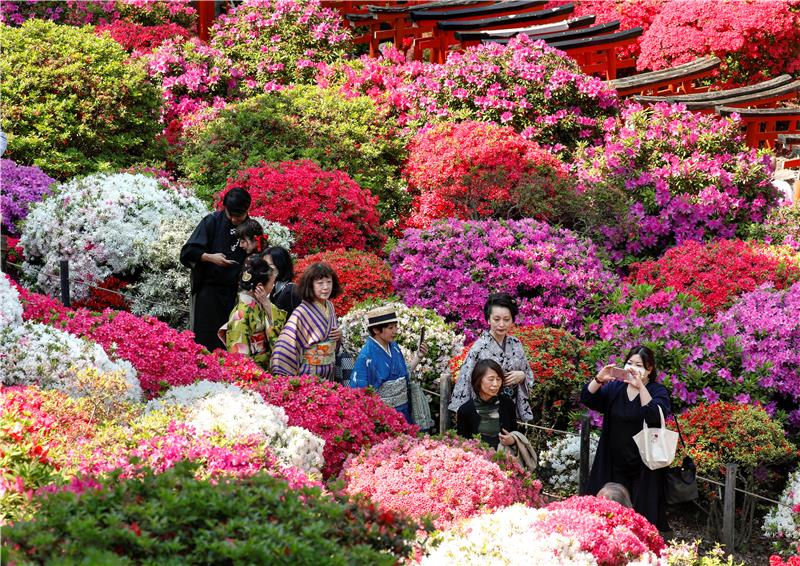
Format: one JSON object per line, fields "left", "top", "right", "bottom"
{"left": 421, "top": 504, "right": 597, "bottom": 566}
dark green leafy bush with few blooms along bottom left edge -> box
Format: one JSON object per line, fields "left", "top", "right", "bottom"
{"left": 2, "top": 462, "right": 424, "bottom": 565}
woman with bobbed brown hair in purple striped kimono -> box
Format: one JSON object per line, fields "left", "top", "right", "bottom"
{"left": 272, "top": 262, "right": 342, "bottom": 380}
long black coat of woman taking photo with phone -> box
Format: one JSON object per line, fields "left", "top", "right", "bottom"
{"left": 581, "top": 381, "right": 671, "bottom": 531}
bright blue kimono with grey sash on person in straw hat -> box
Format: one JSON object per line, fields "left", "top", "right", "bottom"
{"left": 349, "top": 337, "right": 414, "bottom": 424}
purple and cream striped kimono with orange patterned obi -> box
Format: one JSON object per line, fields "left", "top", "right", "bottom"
{"left": 271, "top": 301, "right": 338, "bottom": 380}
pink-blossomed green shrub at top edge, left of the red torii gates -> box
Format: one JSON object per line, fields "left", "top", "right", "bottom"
{"left": 211, "top": 0, "right": 350, "bottom": 92}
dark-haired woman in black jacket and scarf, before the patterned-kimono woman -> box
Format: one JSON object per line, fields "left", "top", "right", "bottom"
{"left": 456, "top": 359, "right": 517, "bottom": 450}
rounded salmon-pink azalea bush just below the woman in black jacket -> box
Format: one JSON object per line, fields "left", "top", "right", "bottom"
{"left": 340, "top": 436, "right": 541, "bottom": 529}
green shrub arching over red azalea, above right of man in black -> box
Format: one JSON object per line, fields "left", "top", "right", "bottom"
{"left": 179, "top": 86, "right": 409, "bottom": 218}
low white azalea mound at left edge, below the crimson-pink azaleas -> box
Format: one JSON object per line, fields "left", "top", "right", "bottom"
{"left": 0, "top": 322, "right": 142, "bottom": 402}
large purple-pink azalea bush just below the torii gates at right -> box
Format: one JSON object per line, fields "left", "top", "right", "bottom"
{"left": 575, "top": 103, "right": 777, "bottom": 261}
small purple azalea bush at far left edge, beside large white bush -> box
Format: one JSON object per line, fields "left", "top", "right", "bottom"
{"left": 0, "top": 159, "right": 56, "bottom": 236}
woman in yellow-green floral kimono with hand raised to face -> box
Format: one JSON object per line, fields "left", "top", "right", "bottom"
{"left": 219, "top": 256, "right": 286, "bottom": 370}
